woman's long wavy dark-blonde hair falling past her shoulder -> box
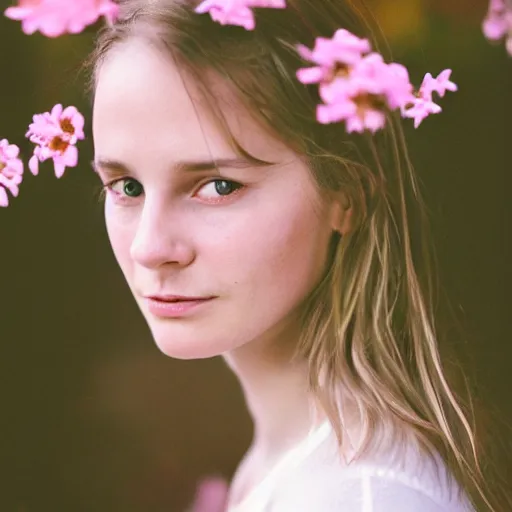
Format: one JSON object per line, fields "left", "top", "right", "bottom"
{"left": 91, "top": 0, "right": 512, "bottom": 512}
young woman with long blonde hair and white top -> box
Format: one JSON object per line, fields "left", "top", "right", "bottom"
{"left": 93, "top": 0, "right": 512, "bottom": 512}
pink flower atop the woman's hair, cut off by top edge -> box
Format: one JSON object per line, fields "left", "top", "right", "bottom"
{"left": 195, "top": 0, "right": 286, "bottom": 30}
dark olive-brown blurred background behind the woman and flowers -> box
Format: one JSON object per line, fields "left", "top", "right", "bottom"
{"left": 0, "top": 0, "right": 512, "bottom": 512}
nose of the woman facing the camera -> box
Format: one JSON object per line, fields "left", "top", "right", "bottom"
{"left": 130, "top": 203, "right": 195, "bottom": 268}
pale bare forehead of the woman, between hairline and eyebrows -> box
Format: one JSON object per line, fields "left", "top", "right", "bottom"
{"left": 93, "top": 39, "right": 293, "bottom": 166}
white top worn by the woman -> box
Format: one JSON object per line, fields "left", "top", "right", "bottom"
{"left": 226, "top": 422, "right": 474, "bottom": 512}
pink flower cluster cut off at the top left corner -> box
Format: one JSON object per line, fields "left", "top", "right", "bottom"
{"left": 5, "top": 0, "right": 119, "bottom": 37}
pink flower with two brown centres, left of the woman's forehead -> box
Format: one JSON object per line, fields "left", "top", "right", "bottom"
{"left": 26, "top": 104, "right": 85, "bottom": 178}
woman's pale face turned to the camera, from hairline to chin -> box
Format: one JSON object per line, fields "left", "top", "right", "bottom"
{"left": 93, "top": 40, "right": 346, "bottom": 359}
